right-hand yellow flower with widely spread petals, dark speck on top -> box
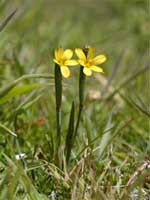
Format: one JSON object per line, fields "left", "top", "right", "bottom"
{"left": 75, "top": 47, "right": 106, "bottom": 76}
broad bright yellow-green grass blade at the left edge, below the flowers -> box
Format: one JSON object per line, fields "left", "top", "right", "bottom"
{"left": 0, "top": 83, "right": 48, "bottom": 104}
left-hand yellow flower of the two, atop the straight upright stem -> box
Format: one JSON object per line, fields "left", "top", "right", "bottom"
{"left": 53, "top": 48, "right": 78, "bottom": 78}
